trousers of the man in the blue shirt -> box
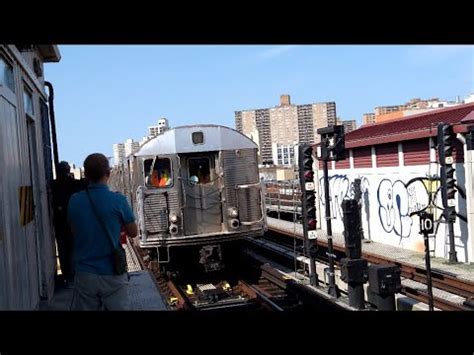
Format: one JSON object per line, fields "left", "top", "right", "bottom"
{"left": 71, "top": 272, "right": 130, "bottom": 311}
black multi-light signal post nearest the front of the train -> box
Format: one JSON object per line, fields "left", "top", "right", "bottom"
{"left": 298, "top": 144, "right": 318, "bottom": 286}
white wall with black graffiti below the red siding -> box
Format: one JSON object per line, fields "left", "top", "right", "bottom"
{"left": 318, "top": 164, "right": 473, "bottom": 262}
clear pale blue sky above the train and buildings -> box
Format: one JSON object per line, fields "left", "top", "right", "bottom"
{"left": 45, "top": 45, "right": 474, "bottom": 166}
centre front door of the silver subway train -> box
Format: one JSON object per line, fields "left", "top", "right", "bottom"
{"left": 181, "top": 152, "right": 222, "bottom": 235}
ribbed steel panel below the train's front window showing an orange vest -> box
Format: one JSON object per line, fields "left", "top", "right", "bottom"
{"left": 143, "top": 190, "right": 179, "bottom": 234}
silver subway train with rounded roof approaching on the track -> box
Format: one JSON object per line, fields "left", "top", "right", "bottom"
{"left": 110, "top": 125, "right": 267, "bottom": 263}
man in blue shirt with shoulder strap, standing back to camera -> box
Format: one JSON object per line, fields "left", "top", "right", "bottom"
{"left": 68, "top": 153, "right": 138, "bottom": 310}
